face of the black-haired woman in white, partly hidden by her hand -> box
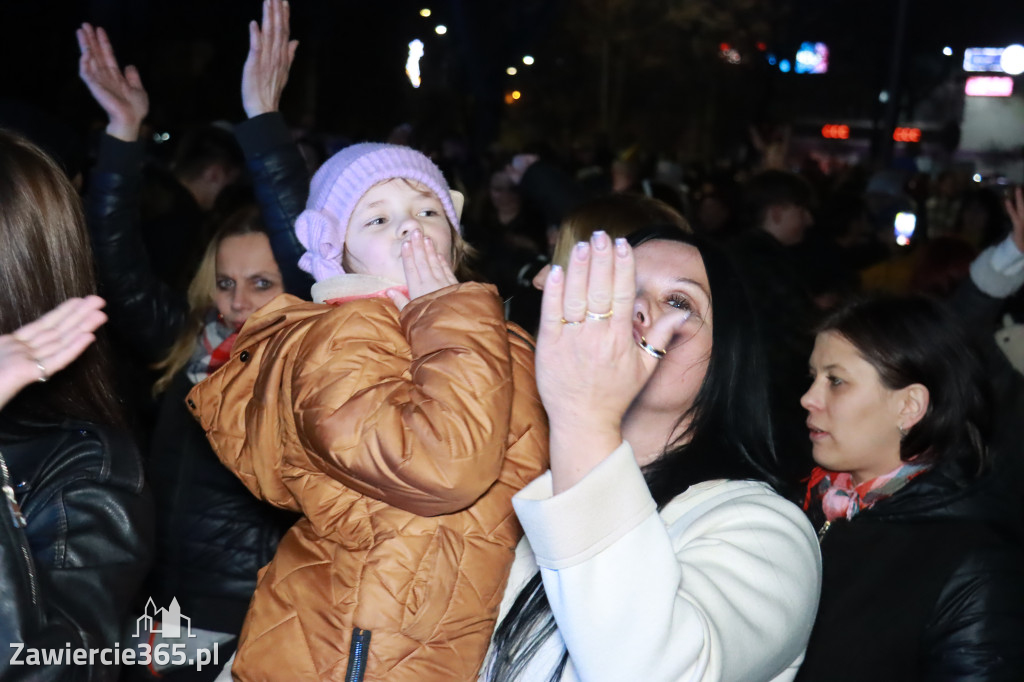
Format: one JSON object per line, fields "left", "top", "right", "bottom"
{"left": 627, "top": 240, "right": 712, "bottom": 456}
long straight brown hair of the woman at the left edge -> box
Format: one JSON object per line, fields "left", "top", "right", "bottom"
{"left": 0, "top": 130, "right": 124, "bottom": 426}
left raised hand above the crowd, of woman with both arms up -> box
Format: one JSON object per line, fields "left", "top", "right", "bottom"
{"left": 75, "top": 24, "right": 150, "bottom": 142}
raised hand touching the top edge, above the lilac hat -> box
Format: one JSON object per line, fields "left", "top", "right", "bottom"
{"left": 242, "top": 0, "right": 299, "bottom": 118}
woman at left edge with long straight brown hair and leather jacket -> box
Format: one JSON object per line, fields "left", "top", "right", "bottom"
{"left": 0, "top": 131, "right": 153, "bottom": 680}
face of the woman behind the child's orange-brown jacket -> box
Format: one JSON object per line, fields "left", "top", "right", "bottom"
{"left": 213, "top": 232, "right": 285, "bottom": 331}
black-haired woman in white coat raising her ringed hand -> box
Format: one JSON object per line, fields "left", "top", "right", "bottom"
{"left": 481, "top": 227, "right": 820, "bottom": 681}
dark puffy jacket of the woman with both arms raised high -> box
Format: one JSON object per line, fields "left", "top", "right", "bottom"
{"left": 86, "top": 113, "right": 311, "bottom": 633}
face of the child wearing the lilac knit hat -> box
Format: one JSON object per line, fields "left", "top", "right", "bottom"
{"left": 342, "top": 178, "right": 453, "bottom": 283}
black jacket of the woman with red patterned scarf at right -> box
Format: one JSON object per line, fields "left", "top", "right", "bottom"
{"left": 797, "top": 462, "right": 1024, "bottom": 682}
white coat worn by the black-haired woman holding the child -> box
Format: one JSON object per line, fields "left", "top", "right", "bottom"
{"left": 481, "top": 442, "right": 821, "bottom": 682}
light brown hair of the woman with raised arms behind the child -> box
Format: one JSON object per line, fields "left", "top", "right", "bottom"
{"left": 153, "top": 204, "right": 266, "bottom": 394}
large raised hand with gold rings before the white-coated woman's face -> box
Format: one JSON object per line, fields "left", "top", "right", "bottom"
{"left": 537, "top": 231, "right": 686, "bottom": 494}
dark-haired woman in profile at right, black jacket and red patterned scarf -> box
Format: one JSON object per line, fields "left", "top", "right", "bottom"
{"left": 798, "top": 297, "right": 1024, "bottom": 681}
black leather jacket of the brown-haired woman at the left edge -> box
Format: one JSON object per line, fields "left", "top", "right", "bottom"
{"left": 0, "top": 421, "right": 154, "bottom": 682}
